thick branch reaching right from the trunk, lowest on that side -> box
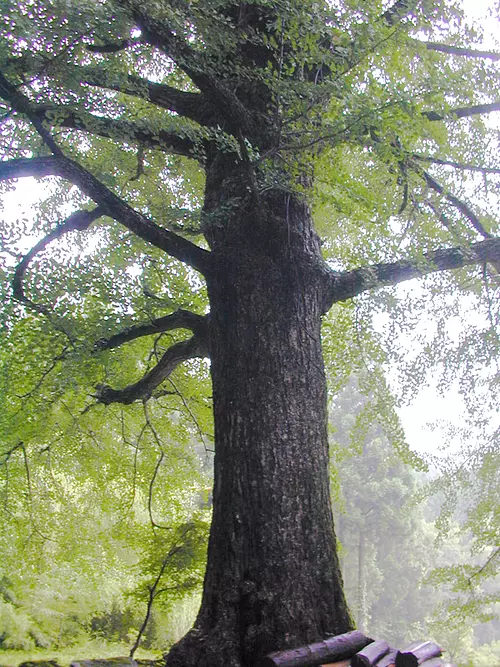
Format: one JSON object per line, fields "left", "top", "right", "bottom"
{"left": 324, "top": 238, "right": 500, "bottom": 312}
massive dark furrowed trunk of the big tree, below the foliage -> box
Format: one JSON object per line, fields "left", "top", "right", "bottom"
{"left": 167, "top": 157, "right": 352, "bottom": 667}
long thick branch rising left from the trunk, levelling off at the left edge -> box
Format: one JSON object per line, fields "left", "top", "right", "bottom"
{"left": 0, "top": 156, "right": 211, "bottom": 274}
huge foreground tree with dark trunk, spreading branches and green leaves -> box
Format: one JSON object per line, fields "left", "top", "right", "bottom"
{"left": 0, "top": 0, "right": 500, "bottom": 667}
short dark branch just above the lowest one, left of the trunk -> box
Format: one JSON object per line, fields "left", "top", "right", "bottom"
{"left": 95, "top": 308, "right": 207, "bottom": 350}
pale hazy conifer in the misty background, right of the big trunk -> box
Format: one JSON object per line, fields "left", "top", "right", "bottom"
{"left": 330, "top": 381, "right": 434, "bottom": 646}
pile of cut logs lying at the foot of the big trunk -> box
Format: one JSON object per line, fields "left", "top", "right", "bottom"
{"left": 257, "top": 630, "right": 455, "bottom": 667}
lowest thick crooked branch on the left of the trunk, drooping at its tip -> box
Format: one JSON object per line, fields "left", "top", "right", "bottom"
{"left": 96, "top": 334, "right": 208, "bottom": 405}
